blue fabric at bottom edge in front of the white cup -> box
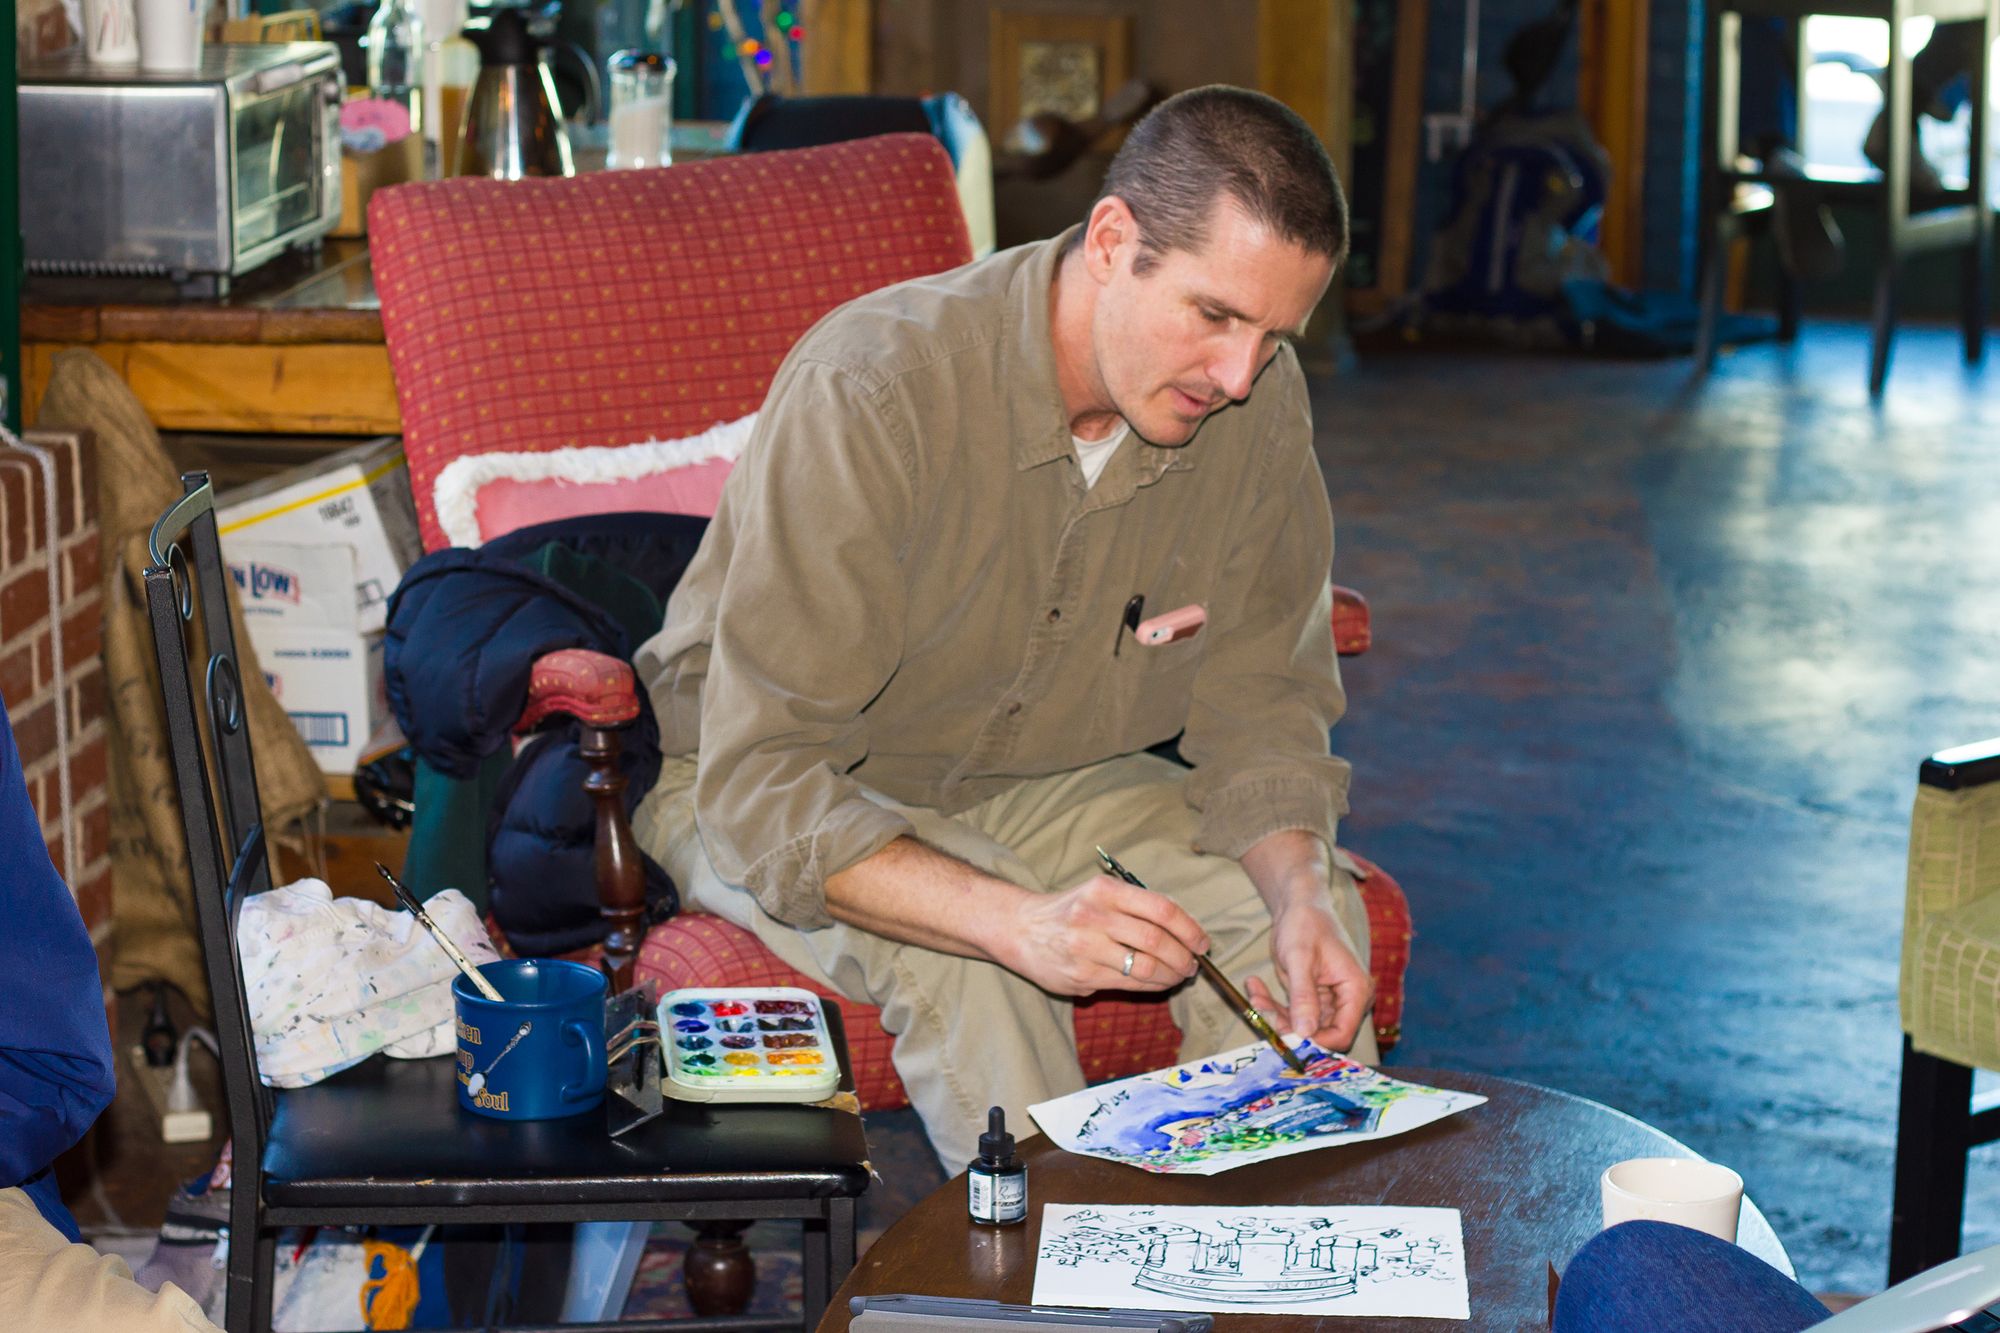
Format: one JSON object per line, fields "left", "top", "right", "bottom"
{"left": 1552, "top": 1221, "right": 1828, "bottom": 1333}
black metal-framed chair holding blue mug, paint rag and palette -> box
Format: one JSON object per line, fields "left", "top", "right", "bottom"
{"left": 144, "top": 472, "right": 868, "bottom": 1333}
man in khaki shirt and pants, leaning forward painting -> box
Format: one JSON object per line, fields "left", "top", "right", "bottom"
{"left": 636, "top": 88, "right": 1376, "bottom": 1169}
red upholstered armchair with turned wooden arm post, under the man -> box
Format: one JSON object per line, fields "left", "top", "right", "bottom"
{"left": 368, "top": 134, "right": 1410, "bottom": 1109}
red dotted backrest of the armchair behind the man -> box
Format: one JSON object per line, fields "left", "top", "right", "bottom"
{"left": 368, "top": 134, "right": 972, "bottom": 550}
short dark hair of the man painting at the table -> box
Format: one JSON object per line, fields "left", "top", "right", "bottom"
{"left": 1098, "top": 84, "right": 1348, "bottom": 274}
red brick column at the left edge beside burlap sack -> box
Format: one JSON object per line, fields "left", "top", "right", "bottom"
{"left": 0, "top": 432, "right": 112, "bottom": 1003}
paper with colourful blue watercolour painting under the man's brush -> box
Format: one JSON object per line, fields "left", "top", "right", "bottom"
{"left": 1028, "top": 1041, "right": 1486, "bottom": 1175}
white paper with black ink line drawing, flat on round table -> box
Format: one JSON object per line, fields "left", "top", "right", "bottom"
{"left": 1034, "top": 1203, "right": 1472, "bottom": 1319}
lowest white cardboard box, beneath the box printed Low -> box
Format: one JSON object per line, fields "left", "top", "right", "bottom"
{"left": 250, "top": 624, "right": 388, "bottom": 775}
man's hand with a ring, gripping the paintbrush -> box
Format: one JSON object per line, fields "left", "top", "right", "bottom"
{"left": 996, "top": 875, "right": 1208, "bottom": 995}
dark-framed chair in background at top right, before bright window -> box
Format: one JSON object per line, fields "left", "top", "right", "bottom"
{"left": 1694, "top": 0, "right": 2000, "bottom": 396}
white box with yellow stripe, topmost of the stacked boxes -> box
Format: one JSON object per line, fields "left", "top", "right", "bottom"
{"left": 216, "top": 438, "right": 424, "bottom": 634}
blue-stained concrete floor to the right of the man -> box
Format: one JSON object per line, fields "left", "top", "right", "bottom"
{"left": 1314, "top": 324, "right": 2000, "bottom": 1291}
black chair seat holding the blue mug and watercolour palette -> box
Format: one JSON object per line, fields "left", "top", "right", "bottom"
{"left": 264, "top": 1055, "right": 868, "bottom": 1209}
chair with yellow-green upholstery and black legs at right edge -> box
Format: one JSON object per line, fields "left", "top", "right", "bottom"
{"left": 1888, "top": 739, "right": 2000, "bottom": 1283}
